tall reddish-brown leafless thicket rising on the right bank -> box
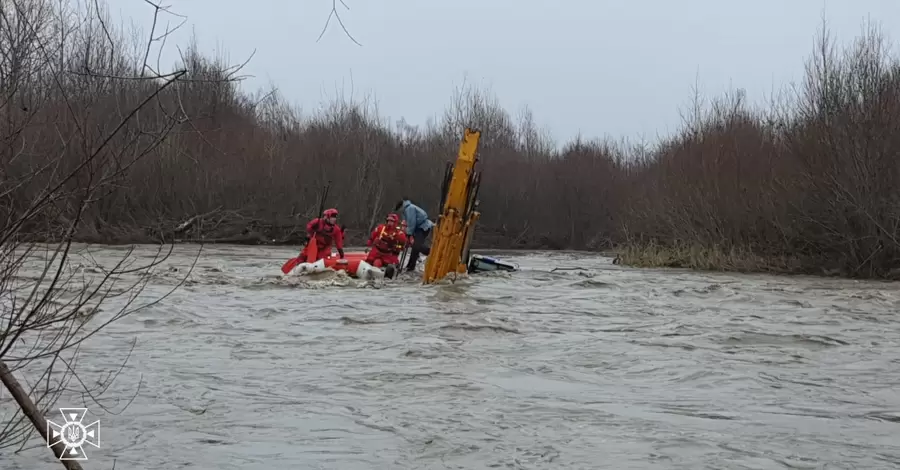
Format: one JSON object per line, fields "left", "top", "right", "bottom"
{"left": 621, "top": 17, "right": 900, "bottom": 277}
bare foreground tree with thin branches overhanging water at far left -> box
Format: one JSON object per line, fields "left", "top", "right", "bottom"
{"left": 0, "top": 0, "right": 246, "bottom": 469}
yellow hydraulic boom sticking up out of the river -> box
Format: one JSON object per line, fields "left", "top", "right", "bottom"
{"left": 424, "top": 128, "right": 481, "bottom": 284}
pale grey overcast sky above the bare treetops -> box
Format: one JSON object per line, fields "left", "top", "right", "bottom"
{"left": 109, "top": 0, "right": 900, "bottom": 146}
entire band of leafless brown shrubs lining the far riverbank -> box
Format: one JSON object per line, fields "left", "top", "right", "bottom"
{"left": 7, "top": 2, "right": 900, "bottom": 277}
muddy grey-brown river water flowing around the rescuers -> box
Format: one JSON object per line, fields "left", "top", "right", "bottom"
{"left": 0, "top": 246, "right": 900, "bottom": 470}
